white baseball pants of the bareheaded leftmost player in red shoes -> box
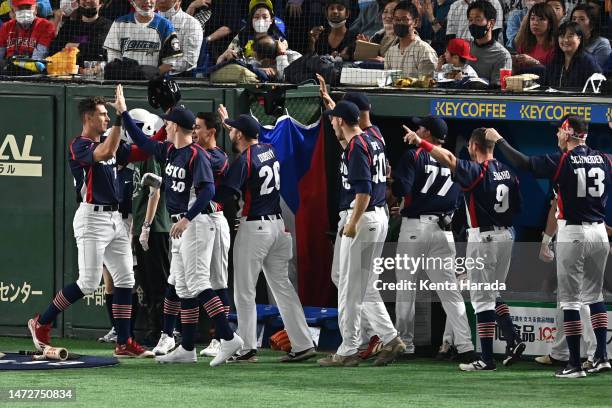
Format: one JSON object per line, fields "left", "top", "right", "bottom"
{"left": 72, "top": 203, "right": 134, "bottom": 295}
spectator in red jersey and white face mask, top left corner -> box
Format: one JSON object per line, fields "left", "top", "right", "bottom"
{"left": 0, "top": 0, "right": 55, "bottom": 65}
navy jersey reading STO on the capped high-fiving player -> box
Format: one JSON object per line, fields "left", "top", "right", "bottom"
{"left": 147, "top": 142, "right": 214, "bottom": 214}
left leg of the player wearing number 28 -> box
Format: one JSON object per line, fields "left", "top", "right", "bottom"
{"left": 233, "top": 219, "right": 274, "bottom": 362}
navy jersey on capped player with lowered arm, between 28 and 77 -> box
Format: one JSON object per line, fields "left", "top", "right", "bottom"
{"left": 341, "top": 133, "right": 387, "bottom": 209}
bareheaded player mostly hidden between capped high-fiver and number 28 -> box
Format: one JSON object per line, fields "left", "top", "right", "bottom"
{"left": 193, "top": 112, "right": 231, "bottom": 357}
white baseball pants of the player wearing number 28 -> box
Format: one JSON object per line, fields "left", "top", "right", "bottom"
{"left": 233, "top": 215, "right": 313, "bottom": 353}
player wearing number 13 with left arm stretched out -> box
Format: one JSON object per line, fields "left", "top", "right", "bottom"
{"left": 487, "top": 116, "right": 612, "bottom": 378}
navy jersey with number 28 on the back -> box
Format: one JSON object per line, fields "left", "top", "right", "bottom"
{"left": 222, "top": 143, "right": 281, "bottom": 217}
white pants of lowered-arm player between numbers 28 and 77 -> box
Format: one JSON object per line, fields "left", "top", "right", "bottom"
{"left": 337, "top": 207, "right": 397, "bottom": 356}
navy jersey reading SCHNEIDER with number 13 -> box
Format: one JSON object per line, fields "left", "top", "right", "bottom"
{"left": 530, "top": 145, "right": 612, "bottom": 223}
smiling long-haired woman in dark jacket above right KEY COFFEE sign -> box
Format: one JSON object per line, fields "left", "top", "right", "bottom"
{"left": 544, "top": 21, "right": 602, "bottom": 89}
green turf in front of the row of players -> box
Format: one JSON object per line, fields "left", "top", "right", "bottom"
{"left": 0, "top": 337, "right": 612, "bottom": 408}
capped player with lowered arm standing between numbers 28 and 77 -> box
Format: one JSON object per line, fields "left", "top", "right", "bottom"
{"left": 318, "top": 101, "right": 406, "bottom": 367}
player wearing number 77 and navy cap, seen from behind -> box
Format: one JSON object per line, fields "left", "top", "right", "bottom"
{"left": 392, "top": 116, "right": 474, "bottom": 362}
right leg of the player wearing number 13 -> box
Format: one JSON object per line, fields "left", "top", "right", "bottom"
{"left": 581, "top": 223, "right": 611, "bottom": 373}
